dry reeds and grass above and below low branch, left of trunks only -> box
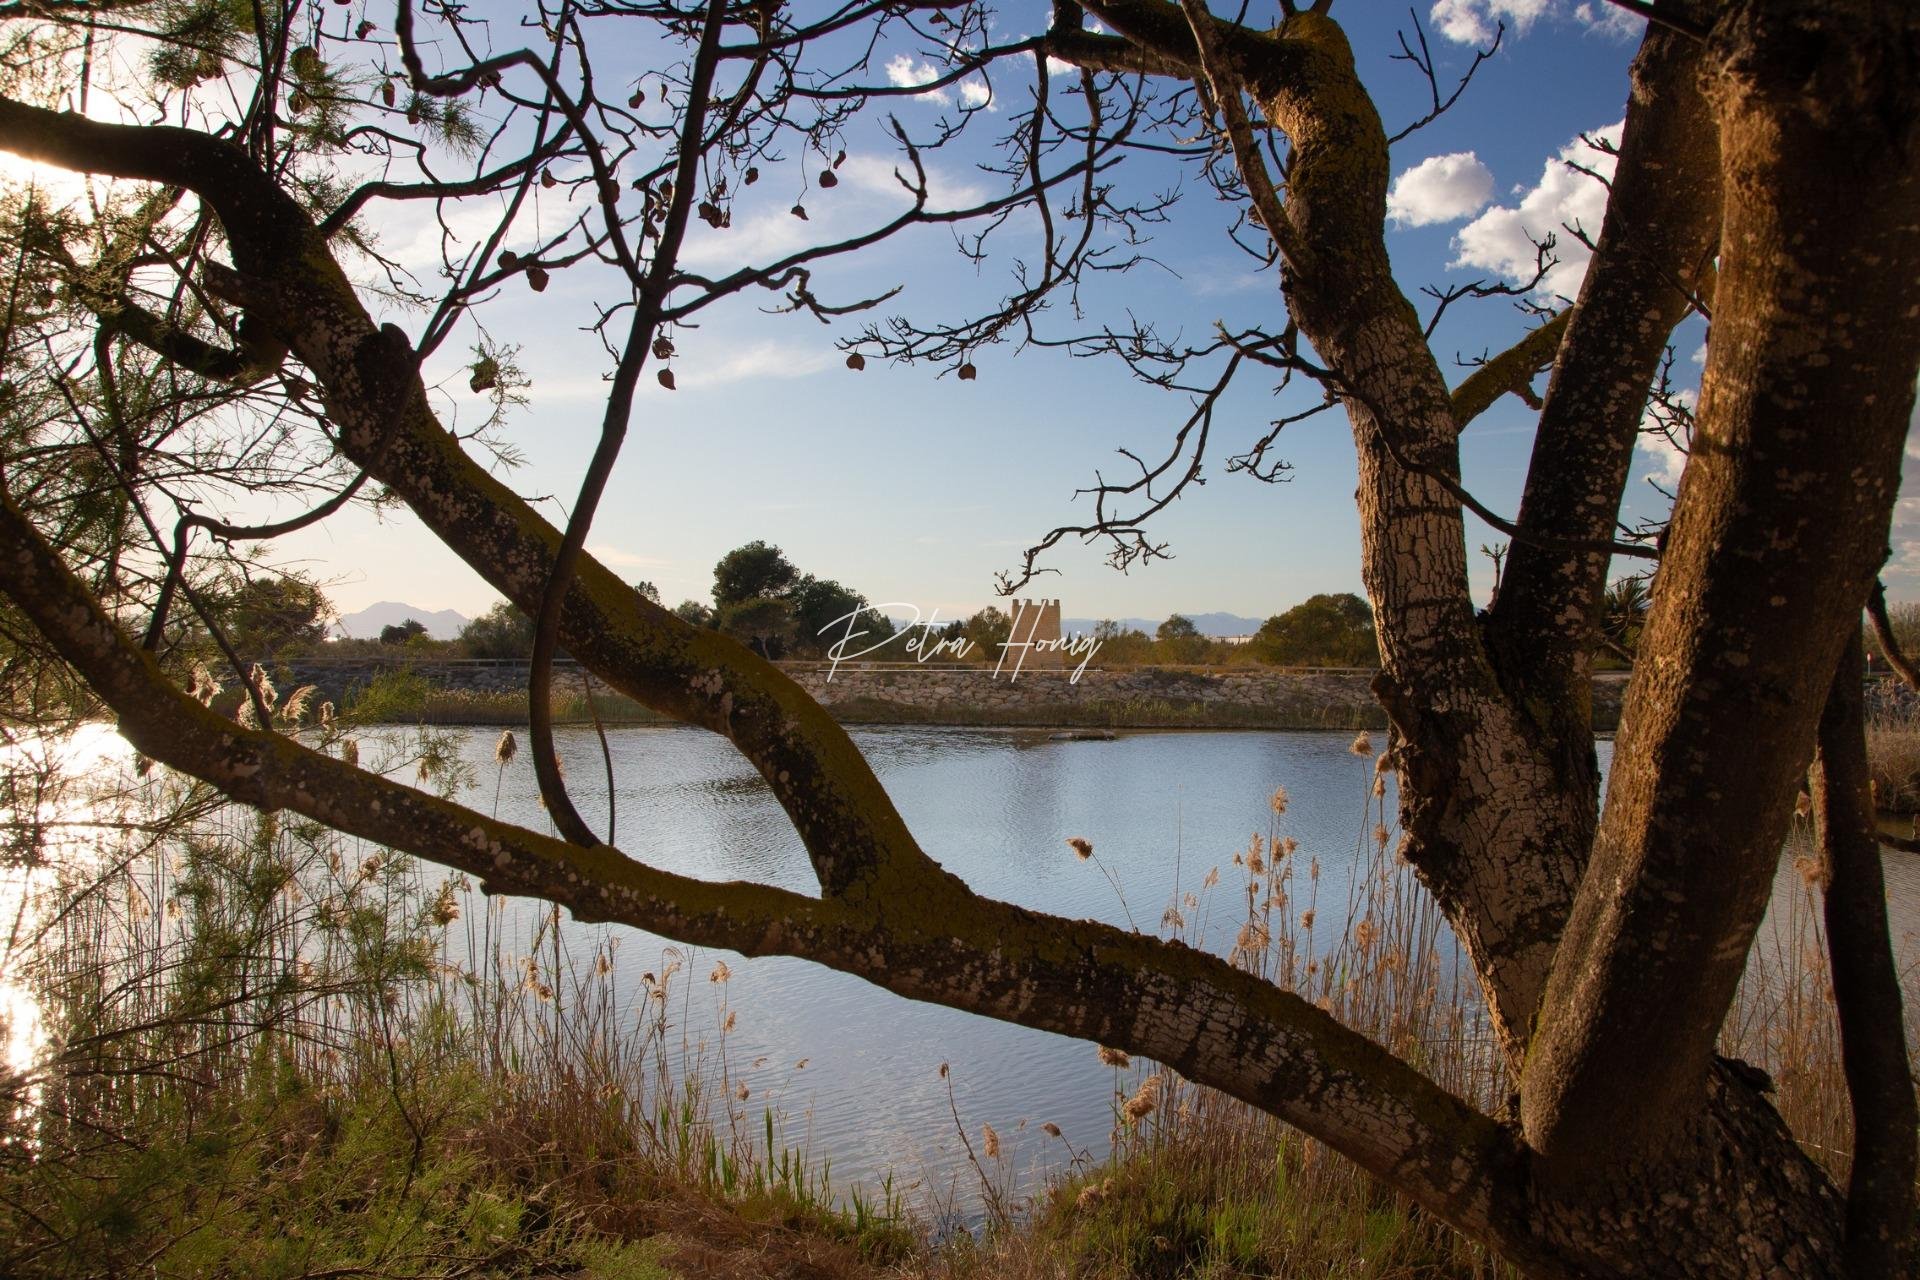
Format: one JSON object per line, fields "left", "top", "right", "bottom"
{"left": 927, "top": 733, "right": 1511, "bottom": 1280}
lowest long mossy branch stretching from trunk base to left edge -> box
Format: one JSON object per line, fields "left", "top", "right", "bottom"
{"left": 0, "top": 479, "right": 1538, "bottom": 1259}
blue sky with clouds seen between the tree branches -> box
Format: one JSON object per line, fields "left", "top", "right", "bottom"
{"left": 263, "top": 0, "right": 1701, "bottom": 618}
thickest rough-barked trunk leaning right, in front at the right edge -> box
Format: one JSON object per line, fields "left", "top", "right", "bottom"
{"left": 1521, "top": 2, "right": 1920, "bottom": 1184}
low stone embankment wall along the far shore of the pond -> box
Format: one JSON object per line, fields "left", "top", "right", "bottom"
{"left": 280, "top": 658, "right": 1624, "bottom": 729}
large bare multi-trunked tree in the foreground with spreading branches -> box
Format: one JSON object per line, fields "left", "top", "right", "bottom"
{"left": 0, "top": 0, "right": 1920, "bottom": 1276}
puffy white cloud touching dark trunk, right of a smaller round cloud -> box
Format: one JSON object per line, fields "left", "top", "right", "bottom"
{"left": 1452, "top": 125, "right": 1622, "bottom": 297}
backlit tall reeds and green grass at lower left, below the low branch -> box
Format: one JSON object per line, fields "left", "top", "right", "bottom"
{"left": 0, "top": 737, "right": 914, "bottom": 1276}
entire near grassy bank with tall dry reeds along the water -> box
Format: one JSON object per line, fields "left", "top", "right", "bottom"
{"left": 0, "top": 737, "right": 1889, "bottom": 1280}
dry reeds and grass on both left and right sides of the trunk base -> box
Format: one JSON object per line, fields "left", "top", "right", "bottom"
{"left": 920, "top": 735, "right": 1920, "bottom": 1280}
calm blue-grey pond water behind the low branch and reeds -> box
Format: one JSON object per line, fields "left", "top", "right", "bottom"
{"left": 441, "top": 727, "right": 1920, "bottom": 1205}
